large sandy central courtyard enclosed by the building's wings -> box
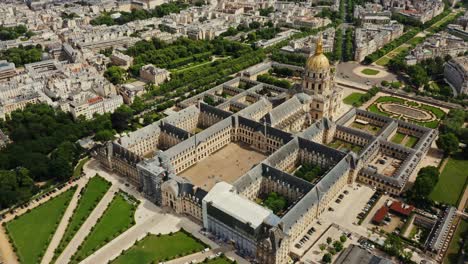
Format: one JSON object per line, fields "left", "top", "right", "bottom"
{"left": 180, "top": 143, "right": 267, "bottom": 191}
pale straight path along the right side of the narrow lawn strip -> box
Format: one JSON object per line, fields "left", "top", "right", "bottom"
{"left": 56, "top": 186, "right": 118, "bottom": 264}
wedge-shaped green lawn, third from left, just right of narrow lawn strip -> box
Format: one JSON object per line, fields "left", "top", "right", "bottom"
{"left": 72, "top": 193, "right": 137, "bottom": 263}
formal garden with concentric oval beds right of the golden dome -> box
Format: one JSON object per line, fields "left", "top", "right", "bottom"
{"left": 367, "top": 96, "right": 445, "bottom": 128}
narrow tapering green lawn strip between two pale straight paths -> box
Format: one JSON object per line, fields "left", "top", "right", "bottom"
{"left": 55, "top": 175, "right": 111, "bottom": 257}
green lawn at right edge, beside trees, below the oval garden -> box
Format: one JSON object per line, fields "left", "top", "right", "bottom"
{"left": 429, "top": 153, "right": 468, "bottom": 205}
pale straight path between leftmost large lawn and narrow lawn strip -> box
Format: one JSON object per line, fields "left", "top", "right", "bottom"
{"left": 41, "top": 177, "right": 89, "bottom": 264}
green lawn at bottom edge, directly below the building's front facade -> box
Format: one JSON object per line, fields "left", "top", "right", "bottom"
{"left": 112, "top": 231, "right": 207, "bottom": 264}
